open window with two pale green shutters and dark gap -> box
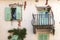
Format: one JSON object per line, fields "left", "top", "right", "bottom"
{"left": 5, "top": 6, "right": 22, "bottom": 21}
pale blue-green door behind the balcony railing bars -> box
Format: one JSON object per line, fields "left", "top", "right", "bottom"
{"left": 38, "top": 11, "right": 49, "bottom": 25}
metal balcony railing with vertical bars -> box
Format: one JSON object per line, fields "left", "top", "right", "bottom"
{"left": 32, "top": 14, "right": 55, "bottom": 25}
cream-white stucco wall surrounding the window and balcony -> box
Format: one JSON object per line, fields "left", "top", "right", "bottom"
{"left": 0, "top": 1, "right": 60, "bottom": 40}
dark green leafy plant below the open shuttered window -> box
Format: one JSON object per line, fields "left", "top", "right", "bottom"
{"left": 8, "top": 28, "right": 26, "bottom": 40}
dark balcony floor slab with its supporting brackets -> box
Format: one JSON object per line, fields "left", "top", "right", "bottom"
{"left": 33, "top": 25, "right": 55, "bottom": 35}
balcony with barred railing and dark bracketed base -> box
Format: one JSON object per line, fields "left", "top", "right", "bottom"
{"left": 32, "top": 6, "right": 55, "bottom": 34}
